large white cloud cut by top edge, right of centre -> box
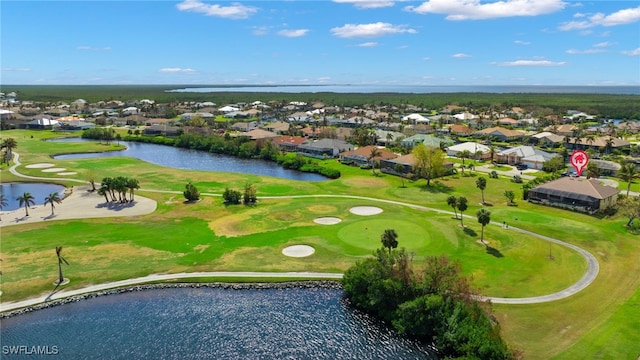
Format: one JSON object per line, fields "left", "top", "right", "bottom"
{"left": 405, "top": 0, "right": 566, "bottom": 20}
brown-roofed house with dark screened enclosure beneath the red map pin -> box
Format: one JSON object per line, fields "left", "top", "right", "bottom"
{"left": 527, "top": 177, "right": 620, "bottom": 213}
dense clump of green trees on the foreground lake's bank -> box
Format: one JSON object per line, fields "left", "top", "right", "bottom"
{"left": 343, "top": 248, "right": 516, "bottom": 359}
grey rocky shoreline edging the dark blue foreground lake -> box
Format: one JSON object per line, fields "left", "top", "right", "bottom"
{"left": 0, "top": 280, "right": 342, "bottom": 319}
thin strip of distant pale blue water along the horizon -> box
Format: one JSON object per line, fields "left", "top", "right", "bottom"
{"left": 167, "top": 85, "right": 640, "bottom": 95}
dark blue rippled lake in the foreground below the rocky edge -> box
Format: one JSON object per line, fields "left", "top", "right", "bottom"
{"left": 1, "top": 288, "right": 434, "bottom": 360}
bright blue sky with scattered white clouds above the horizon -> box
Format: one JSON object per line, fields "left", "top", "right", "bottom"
{"left": 0, "top": 0, "right": 640, "bottom": 86}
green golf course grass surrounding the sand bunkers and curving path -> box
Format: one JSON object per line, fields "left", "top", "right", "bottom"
{"left": 0, "top": 130, "right": 640, "bottom": 359}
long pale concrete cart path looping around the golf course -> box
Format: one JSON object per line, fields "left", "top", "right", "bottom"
{"left": 0, "top": 152, "right": 600, "bottom": 312}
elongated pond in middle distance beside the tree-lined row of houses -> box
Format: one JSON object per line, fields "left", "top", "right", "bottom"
{"left": 52, "top": 138, "right": 327, "bottom": 181}
